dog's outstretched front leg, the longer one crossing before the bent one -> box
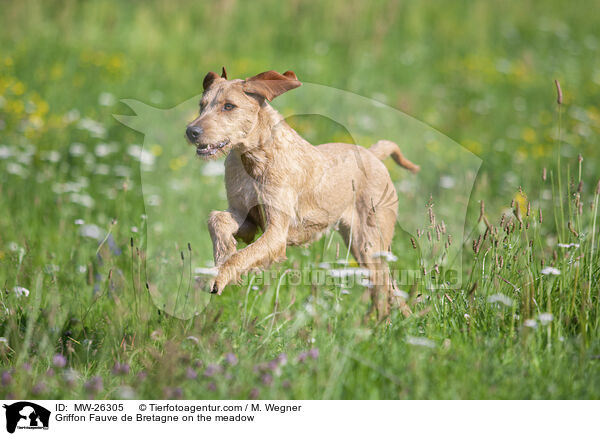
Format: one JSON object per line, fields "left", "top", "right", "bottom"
{"left": 211, "top": 215, "right": 289, "bottom": 294}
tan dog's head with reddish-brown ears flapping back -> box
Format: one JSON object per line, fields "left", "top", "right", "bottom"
{"left": 186, "top": 68, "right": 301, "bottom": 159}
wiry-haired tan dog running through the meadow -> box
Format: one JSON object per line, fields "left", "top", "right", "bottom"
{"left": 186, "top": 68, "right": 419, "bottom": 318}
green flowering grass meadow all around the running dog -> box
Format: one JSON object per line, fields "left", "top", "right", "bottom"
{"left": 0, "top": 0, "right": 600, "bottom": 399}
